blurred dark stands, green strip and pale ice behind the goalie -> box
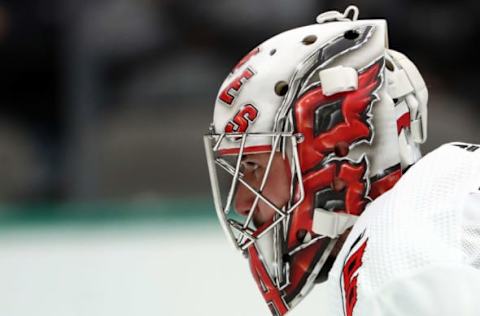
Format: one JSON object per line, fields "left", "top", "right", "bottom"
{"left": 0, "top": 0, "right": 480, "bottom": 316}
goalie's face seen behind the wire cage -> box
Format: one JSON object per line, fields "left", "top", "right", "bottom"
{"left": 235, "top": 153, "right": 291, "bottom": 228}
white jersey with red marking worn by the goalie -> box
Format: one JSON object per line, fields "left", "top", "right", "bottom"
{"left": 298, "top": 143, "right": 480, "bottom": 316}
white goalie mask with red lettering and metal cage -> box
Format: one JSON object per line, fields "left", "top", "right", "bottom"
{"left": 204, "top": 6, "right": 427, "bottom": 315}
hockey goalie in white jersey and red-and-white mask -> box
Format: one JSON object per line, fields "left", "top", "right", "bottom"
{"left": 205, "top": 6, "right": 480, "bottom": 316}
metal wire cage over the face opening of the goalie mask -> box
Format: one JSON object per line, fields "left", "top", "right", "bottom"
{"left": 204, "top": 133, "right": 304, "bottom": 251}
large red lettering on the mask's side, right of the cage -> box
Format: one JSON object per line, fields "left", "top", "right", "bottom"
{"left": 289, "top": 63, "right": 382, "bottom": 248}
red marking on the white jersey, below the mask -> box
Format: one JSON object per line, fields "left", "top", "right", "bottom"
{"left": 342, "top": 239, "right": 368, "bottom": 316}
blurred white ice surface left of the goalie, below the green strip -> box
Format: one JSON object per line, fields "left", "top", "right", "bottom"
{"left": 0, "top": 223, "right": 269, "bottom": 316}
